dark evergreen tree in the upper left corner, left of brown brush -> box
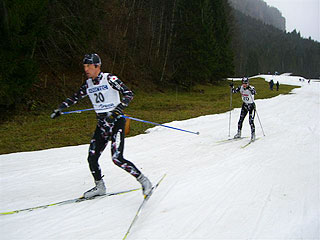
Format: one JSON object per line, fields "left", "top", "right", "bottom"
{"left": 0, "top": 0, "right": 47, "bottom": 108}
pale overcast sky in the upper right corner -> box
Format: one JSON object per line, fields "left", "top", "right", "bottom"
{"left": 264, "top": 0, "right": 320, "bottom": 42}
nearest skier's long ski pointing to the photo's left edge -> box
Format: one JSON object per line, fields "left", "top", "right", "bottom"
{"left": 0, "top": 188, "right": 141, "bottom": 215}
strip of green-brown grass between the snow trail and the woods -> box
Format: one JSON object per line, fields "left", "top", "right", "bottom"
{"left": 0, "top": 79, "right": 295, "bottom": 154}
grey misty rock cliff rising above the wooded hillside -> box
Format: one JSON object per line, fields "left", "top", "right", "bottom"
{"left": 229, "top": 0, "right": 286, "bottom": 31}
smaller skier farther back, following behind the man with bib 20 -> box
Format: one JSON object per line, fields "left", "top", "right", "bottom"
{"left": 230, "top": 77, "right": 257, "bottom": 141}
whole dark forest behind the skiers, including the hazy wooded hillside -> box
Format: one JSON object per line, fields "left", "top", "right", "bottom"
{"left": 0, "top": 0, "right": 320, "bottom": 111}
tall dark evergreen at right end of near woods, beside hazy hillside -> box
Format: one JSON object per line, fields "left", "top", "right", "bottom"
{"left": 173, "top": 0, "right": 232, "bottom": 88}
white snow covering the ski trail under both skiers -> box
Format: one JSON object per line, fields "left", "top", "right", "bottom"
{"left": 0, "top": 76, "right": 320, "bottom": 240}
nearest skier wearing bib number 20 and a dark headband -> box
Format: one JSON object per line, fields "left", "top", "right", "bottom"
{"left": 51, "top": 53, "right": 152, "bottom": 198}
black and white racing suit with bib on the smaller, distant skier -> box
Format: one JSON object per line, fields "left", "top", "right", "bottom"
{"left": 232, "top": 86, "right": 257, "bottom": 134}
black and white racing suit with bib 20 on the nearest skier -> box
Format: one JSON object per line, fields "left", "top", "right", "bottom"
{"left": 59, "top": 72, "right": 141, "bottom": 181}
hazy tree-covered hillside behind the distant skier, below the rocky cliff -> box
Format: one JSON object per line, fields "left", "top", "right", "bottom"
{"left": 232, "top": 10, "right": 320, "bottom": 78}
